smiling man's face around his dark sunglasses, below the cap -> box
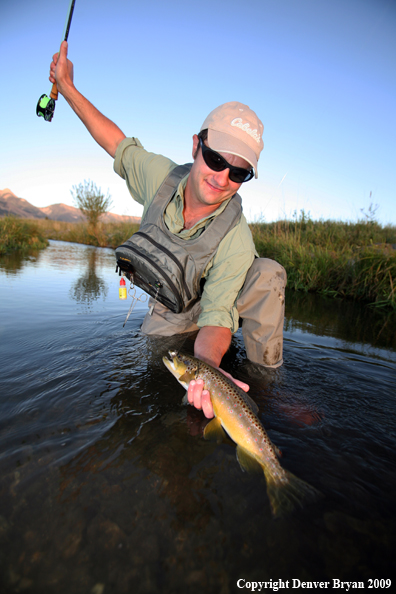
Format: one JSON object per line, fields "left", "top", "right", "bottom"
{"left": 186, "top": 134, "right": 251, "bottom": 210}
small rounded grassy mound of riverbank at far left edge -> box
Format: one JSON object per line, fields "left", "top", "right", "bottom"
{"left": 0, "top": 217, "right": 48, "bottom": 255}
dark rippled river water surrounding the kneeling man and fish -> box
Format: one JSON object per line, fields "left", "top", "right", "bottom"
{"left": 0, "top": 242, "right": 396, "bottom": 594}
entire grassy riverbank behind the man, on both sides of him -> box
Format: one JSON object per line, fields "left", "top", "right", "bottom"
{"left": 0, "top": 211, "right": 396, "bottom": 310}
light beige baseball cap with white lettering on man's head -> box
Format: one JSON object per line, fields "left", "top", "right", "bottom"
{"left": 201, "top": 101, "right": 264, "bottom": 177}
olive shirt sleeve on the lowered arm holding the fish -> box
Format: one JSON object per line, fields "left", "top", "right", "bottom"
{"left": 197, "top": 215, "right": 256, "bottom": 334}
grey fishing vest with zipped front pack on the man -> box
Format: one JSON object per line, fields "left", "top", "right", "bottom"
{"left": 116, "top": 163, "right": 242, "bottom": 313}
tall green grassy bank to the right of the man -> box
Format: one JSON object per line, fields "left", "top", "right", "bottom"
{"left": 251, "top": 213, "right": 396, "bottom": 309}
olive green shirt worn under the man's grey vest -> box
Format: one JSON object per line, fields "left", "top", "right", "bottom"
{"left": 114, "top": 138, "right": 257, "bottom": 333}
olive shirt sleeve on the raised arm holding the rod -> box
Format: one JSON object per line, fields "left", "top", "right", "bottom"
{"left": 114, "top": 138, "right": 176, "bottom": 210}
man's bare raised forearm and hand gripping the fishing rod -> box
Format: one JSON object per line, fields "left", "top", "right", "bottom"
{"left": 49, "top": 41, "right": 125, "bottom": 158}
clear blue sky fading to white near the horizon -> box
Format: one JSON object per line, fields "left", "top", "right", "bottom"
{"left": 0, "top": 0, "right": 396, "bottom": 225}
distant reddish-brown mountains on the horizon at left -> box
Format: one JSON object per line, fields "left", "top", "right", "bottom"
{"left": 0, "top": 188, "right": 141, "bottom": 224}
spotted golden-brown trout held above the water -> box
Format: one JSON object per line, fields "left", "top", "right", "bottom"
{"left": 163, "top": 351, "right": 319, "bottom": 517}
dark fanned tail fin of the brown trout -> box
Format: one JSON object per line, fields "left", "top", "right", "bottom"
{"left": 263, "top": 467, "right": 321, "bottom": 518}
